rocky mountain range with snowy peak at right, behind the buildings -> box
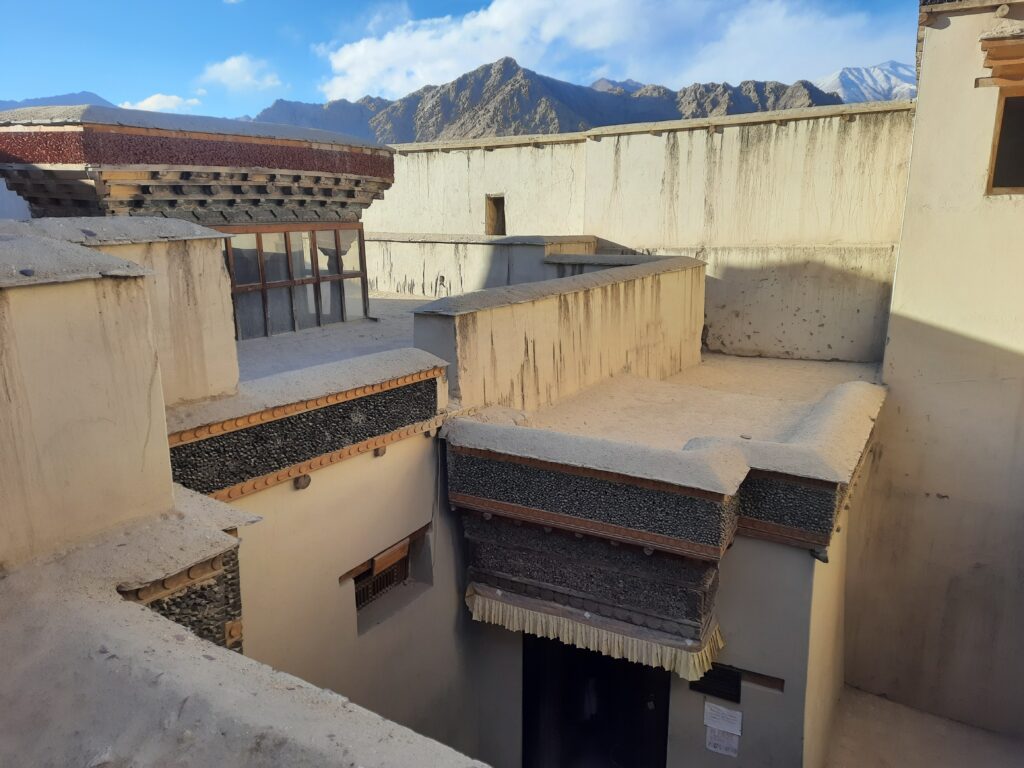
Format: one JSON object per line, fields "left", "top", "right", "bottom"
{"left": 0, "top": 57, "right": 916, "bottom": 143}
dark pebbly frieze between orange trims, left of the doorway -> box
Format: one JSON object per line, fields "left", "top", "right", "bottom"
{"left": 171, "top": 379, "right": 437, "bottom": 494}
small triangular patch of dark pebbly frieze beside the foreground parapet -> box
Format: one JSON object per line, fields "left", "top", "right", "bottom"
{"left": 150, "top": 547, "right": 242, "bottom": 653}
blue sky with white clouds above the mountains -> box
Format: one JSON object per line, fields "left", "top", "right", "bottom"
{"left": 0, "top": 0, "right": 918, "bottom": 117}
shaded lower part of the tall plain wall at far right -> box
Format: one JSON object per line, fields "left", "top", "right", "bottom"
{"left": 847, "top": 315, "right": 1024, "bottom": 736}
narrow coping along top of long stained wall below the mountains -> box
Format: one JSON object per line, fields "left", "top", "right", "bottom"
{"left": 392, "top": 101, "right": 916, "bottom": 155}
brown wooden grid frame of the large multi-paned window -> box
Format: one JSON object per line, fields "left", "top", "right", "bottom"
{"left": 212, "top": 221, "right": 370, "bottom": 341}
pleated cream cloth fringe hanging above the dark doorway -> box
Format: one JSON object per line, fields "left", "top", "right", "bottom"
{"left": 466, "top": 583, "right": 725, "bottom": 680}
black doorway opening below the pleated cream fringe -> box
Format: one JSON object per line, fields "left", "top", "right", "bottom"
{"left": 522, "top": 635, "right": 670, "bottom": 768}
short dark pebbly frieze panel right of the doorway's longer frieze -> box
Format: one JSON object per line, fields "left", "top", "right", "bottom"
{"left": 739, "top": 474, "right": 847, "bottom": 544}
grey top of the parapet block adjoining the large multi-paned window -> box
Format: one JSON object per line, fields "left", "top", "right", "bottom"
{"left": 0, "top": 216, "right": 224, "bottom": 246}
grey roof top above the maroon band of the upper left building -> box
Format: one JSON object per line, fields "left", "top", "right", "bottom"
{"left": 0, "top": 104, "right": 390, "bottom": 152}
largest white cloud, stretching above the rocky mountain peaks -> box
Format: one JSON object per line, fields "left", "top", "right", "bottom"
{"left": 315, "top": 0, "right": 915, "bottom": 99}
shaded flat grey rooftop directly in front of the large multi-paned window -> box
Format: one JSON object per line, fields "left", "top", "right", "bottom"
{"left": 239, "top": 294, "right": 431, "bottom": 381}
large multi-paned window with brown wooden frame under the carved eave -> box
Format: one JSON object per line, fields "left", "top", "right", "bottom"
{"left": 218, "top": 222, "right": 369, "bottom": 340}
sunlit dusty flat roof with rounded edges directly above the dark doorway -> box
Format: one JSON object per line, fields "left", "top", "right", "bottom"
{"left": 475, "top": 354, "right": 885, "bottom": 493}
